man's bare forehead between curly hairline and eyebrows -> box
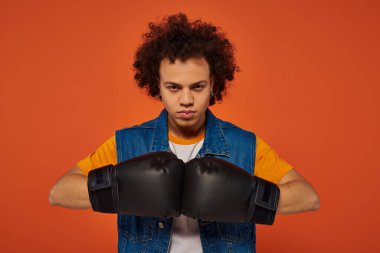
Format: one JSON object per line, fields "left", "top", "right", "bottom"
{"left": 159, "top": 58, "right": 210, "bottom": 84}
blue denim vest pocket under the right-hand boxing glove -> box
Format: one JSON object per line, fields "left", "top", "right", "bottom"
{"left": 216, "top": 222, "right": 254, "bottom": 242}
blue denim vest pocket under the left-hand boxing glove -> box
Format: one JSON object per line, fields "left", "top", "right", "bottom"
{"left": 118, "top": 215, "right": 157, "bottom": 242}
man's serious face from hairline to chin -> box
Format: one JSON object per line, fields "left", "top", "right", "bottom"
{"left": 159, "top": 58, "right": 211, "bottom": 131}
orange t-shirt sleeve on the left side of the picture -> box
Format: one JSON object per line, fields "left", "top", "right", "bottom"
{"left": 77, "top": 135, "right": 117, "bottom": 175}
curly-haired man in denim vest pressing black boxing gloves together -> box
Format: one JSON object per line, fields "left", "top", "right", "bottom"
{"left": 49, "top": 13, "right": 319, "bottom": 253}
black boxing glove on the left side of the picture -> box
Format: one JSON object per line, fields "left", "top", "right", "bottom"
{"left": 87, "top": 152, "right": 185, "bottom": 217}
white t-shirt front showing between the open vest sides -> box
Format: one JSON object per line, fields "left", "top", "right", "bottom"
{"left": 169, "top": 139, "right": 204, "bottom": 253}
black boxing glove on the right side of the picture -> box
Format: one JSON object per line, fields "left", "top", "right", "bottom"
{"left": 182, "top": 157, "right": 280, "bottom": 225}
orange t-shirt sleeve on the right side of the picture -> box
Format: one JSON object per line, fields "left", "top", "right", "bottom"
{"left": 254, "top": 137, "right": 293, "bottom": 184}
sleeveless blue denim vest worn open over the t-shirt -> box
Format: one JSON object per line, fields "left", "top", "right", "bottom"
{"left": 116, "top": 110, "right": 256, "bottom": 253}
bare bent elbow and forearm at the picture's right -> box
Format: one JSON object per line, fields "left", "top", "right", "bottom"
{"left": 277, "top": 169, "right": 319, "bottom": 214}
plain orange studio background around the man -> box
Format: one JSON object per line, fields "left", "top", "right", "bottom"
{"left": 0, "top": 0, "right": 380, "bottom": 253}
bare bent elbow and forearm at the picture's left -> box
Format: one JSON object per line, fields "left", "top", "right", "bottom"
{"left": 49, "top": 166, "right": 91, "bottom": 209}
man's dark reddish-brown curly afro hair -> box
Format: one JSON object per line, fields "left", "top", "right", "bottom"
{"left": 133, "top": 13, "right": 240, "bottom": 105}
